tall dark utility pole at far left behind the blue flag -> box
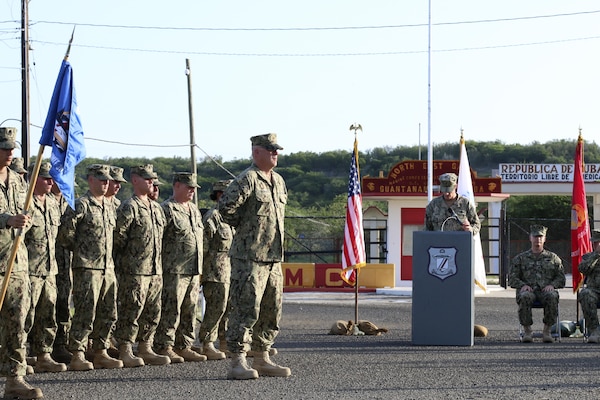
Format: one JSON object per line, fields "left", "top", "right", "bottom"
{"left": 21, "top": 0, "right": 29, "bottom": 169}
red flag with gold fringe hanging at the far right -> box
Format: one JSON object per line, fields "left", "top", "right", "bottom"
{"left": 571, "top": 133, "right": 592, "bottom": 292}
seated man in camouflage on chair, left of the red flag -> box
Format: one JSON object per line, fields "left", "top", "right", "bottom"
{"left": 508, "top": 225, "right": 565, "bottom": 343}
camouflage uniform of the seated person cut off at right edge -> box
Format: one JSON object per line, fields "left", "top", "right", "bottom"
{"left": 577, "top": 251, "right": 600, "bottom": 332}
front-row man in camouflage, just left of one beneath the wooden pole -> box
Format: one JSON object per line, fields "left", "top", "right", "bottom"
{"left": 114, "top": 164, "right": 171, "bottom": 367}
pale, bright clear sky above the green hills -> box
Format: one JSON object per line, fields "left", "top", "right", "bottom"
{"left": 0, "top": 0, "right": 600, "bottom": 161}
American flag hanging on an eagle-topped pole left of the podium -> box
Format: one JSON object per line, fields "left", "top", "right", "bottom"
{"left": 340, "top": 139, "right": 367, "bottom": 286}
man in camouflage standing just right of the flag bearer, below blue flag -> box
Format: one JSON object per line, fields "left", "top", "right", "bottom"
{"left": 25, "top": 162, "right": 67, "bottom": 372}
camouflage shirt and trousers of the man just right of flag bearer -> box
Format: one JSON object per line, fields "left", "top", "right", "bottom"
{"left": 25, "top": 192, "right": 60, "bottom": 355}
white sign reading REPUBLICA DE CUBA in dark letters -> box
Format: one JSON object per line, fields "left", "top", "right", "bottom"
{"left": 498, "top": 164, "right": 600, "bottom": 183}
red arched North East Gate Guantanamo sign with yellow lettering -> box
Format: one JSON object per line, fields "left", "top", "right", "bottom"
{"left": 362, "top": 160, "right": 502, "bottom": 196}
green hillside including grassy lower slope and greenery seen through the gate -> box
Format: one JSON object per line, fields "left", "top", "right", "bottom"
{"left": 56, "top": 140, "right": 600, "bottom": 262}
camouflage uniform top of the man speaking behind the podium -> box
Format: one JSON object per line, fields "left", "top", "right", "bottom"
{"left": 425, "top": 195, "right": 481, "bottom": 235}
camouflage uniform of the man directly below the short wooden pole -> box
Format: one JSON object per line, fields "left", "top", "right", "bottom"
{"left": 154, "top": 197, "right": 203, "bottom": 349}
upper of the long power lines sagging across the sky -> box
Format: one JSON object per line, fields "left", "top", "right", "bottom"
{"left": 29, "top": 10, "right": 600, "bottom": 32}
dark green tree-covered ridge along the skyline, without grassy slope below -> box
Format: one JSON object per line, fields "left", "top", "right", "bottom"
{"left": 69, "top": 140, "right": 600, "bottom": 210}
